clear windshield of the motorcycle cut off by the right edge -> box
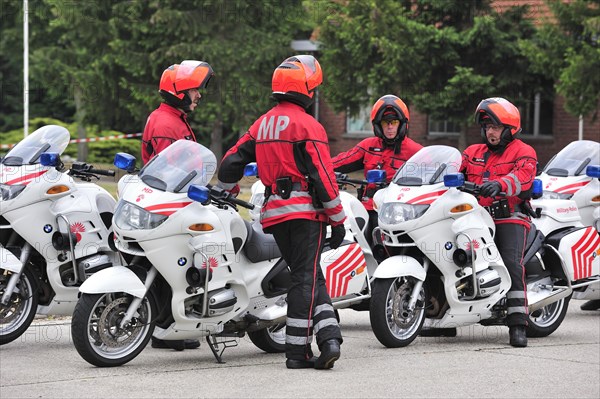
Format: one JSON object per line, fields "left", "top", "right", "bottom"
{"left": 544, "top": 140, "right": 600, "bottom": 177}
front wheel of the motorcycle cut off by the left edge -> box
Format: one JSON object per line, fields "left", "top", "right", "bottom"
{"left": 0, "top": 268, "right": 38, "bottom": 345}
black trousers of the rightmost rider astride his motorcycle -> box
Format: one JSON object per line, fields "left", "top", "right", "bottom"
{"left": 494, "top": 223, "right": 528, "bottom": 327}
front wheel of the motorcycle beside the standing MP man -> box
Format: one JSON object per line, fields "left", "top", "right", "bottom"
{"left": 71, "top": 292, "right": 157, "bottom": 367}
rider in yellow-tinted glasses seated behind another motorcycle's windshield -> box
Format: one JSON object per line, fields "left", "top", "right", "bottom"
{"left": 332, "top": 94, "right": 423, "bottom": 246}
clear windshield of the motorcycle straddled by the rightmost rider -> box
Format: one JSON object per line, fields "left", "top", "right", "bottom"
{"left": 392, "top": 145, "right": 462, "bottom": 186}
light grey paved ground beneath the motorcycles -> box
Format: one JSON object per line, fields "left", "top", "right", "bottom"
{"left": 0, "top": 301, "right": 600, "bottom": 399}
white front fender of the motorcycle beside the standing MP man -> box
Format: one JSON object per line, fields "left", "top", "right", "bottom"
{"left": 79, "top": 266, "right": 146, "bottom": 298}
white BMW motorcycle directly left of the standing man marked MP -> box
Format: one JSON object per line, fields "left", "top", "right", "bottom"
{"left": 71, "top": 140, "right": 380, "bottom": 367}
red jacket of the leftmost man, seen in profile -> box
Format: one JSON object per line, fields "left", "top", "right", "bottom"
{"left": 142, "top": 103, "right": 197, "bottom": 164}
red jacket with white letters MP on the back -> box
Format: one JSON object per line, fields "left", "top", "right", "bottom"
{"left": 218, "top": 102, "right": 345, "bottom": 228}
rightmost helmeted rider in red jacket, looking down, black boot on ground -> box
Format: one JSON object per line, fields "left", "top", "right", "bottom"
{"left": 461, "top": 97, "right": 537, "bottom": 347}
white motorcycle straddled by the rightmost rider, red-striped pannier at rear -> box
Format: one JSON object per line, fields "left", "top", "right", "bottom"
{"left": 370, "top": 146, "right": 600, "bottom": 347}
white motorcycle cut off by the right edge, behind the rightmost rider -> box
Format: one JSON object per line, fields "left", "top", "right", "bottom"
{"left": 532, "top": 140, "right": 600, "bottom": 300}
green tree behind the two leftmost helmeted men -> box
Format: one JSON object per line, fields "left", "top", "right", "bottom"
{"left": 110, "top": 0, "right": 312, "bottom": 159}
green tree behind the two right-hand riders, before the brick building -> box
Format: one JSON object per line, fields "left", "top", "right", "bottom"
{"left": 320, "top": 0, "right": 546, "bottom": 148}
